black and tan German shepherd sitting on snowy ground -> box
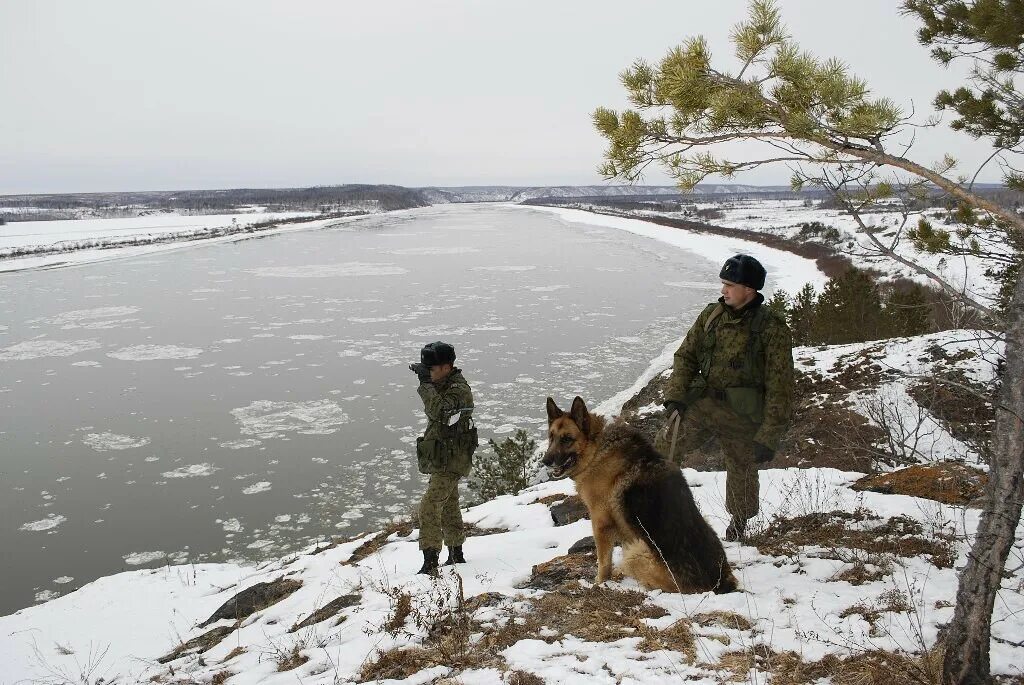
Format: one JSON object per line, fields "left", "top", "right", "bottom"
{"left": 543, "top": 397, "right": 737, "bottom": 593}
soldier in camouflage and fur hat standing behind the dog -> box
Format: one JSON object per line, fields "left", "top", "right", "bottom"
{"left": 655, "top": 255, "right": 793, "bottom": 541}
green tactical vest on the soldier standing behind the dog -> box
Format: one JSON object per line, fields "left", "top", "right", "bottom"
{"left": 685, "top": 302, "right": 773, "bottom": 424}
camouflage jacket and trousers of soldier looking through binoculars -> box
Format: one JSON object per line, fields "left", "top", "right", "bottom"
{"left": 416, "top": 369, "right": 476, "bottom": 550}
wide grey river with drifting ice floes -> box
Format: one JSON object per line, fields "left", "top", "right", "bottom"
{"left": 0, "top": 205, "right": 718, "bottom": 614}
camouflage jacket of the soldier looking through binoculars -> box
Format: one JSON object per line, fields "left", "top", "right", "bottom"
{"left": 417, "top": 369, "right": 476, "bottom": 475}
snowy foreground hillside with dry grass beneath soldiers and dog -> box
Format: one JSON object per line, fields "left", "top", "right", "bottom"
{"left": 0, "top": 331, "right": 1024, "bottom": 685}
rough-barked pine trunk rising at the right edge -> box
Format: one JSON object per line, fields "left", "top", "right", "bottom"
{"left": 942, "top": 270, "right": 1024, "bottom": 685}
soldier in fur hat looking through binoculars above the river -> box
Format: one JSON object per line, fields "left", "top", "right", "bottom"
{"left": 409, "top": 341, "right": 477, "bottom": 573}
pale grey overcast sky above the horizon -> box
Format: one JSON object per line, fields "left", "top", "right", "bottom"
{"left": 0, "top": 0, "right": 998, "bottom": 195}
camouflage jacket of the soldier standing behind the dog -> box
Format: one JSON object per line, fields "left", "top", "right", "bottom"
{"left": 665, "top": 293, "right": 794, "bottom": 449}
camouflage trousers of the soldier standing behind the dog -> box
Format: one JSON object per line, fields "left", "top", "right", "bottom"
{"left": 654, "top": 397, "right": 760, "bottom": 519}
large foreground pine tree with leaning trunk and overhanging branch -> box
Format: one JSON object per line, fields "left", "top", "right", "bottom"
{"left": 593, "top": 0, "right": 1024, "bottom": 685}
